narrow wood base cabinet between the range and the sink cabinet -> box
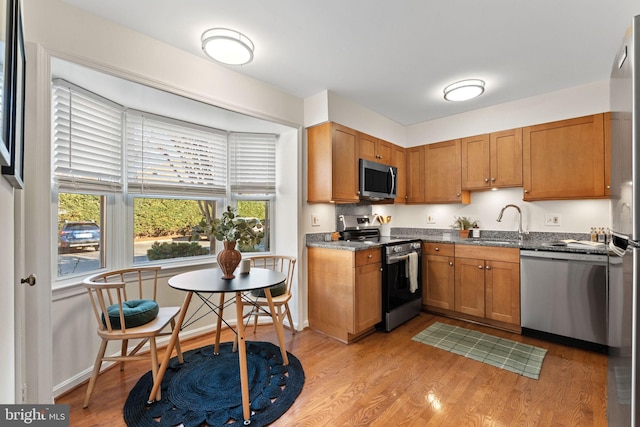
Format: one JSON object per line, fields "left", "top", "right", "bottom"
{"left": 422, "top": 243, "right": 455, "bottom": 310}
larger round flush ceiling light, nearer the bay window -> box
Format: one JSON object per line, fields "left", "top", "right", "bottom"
{"left": 202, "top": 28, "right": 254, "bottom": 65}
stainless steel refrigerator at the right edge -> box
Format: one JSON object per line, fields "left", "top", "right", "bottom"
{"left": 607, "top": 16, "right": 640, "bottom": 426}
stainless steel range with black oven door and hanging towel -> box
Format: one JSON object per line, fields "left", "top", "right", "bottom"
{"left": 338, "top": 215, "right": 422, "bottom": 332}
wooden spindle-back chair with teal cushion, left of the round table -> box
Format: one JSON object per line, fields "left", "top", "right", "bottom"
{"left": 83, "top": 267, "right": 183, "bottom": 408}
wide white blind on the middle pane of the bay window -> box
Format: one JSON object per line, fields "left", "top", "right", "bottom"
{"left": 126, "top": 110, "right": 227, "bottom": 197}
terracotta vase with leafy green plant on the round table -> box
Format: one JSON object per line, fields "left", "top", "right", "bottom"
{"left": 192, "top": 206, "right": 264, "bottom": 279}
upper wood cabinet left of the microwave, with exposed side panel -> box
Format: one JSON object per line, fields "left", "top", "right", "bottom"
{"left": 307, "top": 122, "right": 360, "bottom": 203}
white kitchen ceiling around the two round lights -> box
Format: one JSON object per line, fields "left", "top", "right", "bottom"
{"left": 64, "top": 0, "right": 640, "bottom": 125}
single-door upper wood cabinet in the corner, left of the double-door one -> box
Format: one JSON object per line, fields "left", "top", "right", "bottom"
{"left": 424, "top": 139, "right": 471, "bottom": 203}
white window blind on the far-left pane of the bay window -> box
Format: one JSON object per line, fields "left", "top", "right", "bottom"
{"left": 52, "top": 79, "right": 123, "bottom": 191}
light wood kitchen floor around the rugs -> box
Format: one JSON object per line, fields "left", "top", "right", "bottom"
{"left": 56, "top": 313, "right": 607, "bottom": 427}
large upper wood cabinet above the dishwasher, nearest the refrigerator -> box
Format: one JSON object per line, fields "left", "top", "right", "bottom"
{"left": 523, "top": 114, "right": 607, "bottom": 201}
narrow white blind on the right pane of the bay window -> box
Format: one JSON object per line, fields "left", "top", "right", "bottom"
{"left": 229, "top": 133, "right": 277, "bottom": 194}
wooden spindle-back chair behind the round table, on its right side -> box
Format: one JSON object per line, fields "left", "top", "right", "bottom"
{"left": 243, "top": 255, "right": 296, "bottom": 335}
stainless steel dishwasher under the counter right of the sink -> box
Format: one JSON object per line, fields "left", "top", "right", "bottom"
{"left": 520, "top": 250, "right": 608, "bottom": 352}
